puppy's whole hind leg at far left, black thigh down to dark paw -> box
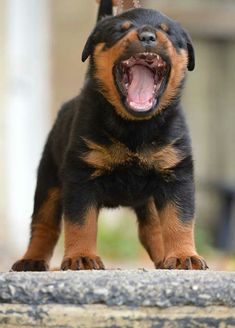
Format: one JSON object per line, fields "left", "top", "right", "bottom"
{"left": 12, "top": 140, "right": 62, "bottom": 271}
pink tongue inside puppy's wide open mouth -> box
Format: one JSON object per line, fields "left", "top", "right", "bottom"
{"left": 128, "top": 65, "right": 154, "bottom": 111}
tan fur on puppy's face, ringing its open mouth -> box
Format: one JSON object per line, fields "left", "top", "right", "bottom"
{"left": 94, "top": 29, "right": 188, "bottom": 120}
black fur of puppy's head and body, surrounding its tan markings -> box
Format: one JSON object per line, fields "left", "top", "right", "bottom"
{"left": 31, "top": 9, "right": 194, "bottom": 228}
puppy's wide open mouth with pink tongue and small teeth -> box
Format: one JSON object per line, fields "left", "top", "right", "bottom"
{"left": 116, "top": 53, "right": 169, "bottom": 114}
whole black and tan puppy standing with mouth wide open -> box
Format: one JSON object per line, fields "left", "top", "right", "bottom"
{"left": 12, "top": 2, "right": 207, "bottom": 271}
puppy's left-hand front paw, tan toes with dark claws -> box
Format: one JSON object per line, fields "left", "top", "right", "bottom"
{"left": 61, "top": 255, "right": 105, "bottom": 271}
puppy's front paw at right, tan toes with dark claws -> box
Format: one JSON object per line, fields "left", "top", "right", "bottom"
{"left": 162, "top": 255, "right": 208, "bottom": 270}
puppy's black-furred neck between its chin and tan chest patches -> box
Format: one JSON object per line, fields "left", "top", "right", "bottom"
{"left": 81, "top": 80, "right": 181, "bottom": 149}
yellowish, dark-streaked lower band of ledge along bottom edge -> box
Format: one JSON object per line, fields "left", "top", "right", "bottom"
{"left": 0, "top": 304, "right": 235, "bottom": 328}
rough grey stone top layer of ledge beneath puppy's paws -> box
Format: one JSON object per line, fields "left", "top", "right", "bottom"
{"left": 0, "top": 270, "right": 235, "bottom": 308}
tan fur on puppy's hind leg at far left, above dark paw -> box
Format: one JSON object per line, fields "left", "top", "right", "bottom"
{"left": 23, "top": 188, "right": 61, "bottom": 261}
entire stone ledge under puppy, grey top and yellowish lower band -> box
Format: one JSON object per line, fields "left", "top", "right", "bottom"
{"left": 0, "top": 270, "right": 235, "bottom": 328}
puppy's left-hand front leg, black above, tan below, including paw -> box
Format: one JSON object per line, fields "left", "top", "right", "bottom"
{"left": 61, "top": 178, "right": 104, "bottom": 270}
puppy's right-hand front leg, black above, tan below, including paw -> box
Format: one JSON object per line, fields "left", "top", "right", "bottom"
{"left": 156, "top": 181, "right": 208, "bottom": 270}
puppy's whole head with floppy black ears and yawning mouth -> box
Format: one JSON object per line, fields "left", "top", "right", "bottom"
{"left": 82, "top": 9, "right": 195, "bottom": 120}
